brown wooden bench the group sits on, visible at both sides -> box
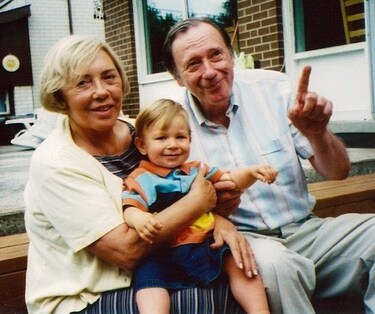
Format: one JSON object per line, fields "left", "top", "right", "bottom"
{"left": 0, "top": 173, "right": 375, "bottom": 313}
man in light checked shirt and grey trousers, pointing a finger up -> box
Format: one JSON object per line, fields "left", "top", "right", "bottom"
{"left": 164, "top": 19, "right": 375, "bottom": 313}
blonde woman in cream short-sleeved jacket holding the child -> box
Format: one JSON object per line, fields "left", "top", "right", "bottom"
{"left": 25, "top": 36, "right": 253, "bottom": 313}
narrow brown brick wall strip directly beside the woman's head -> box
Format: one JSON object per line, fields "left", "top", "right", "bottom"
{"left": 104, "top": 0, "right": 139, "bottom": 117}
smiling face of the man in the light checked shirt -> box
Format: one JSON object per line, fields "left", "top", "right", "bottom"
{"left": 172, "top": 23, "right": 234, "bottom": 110}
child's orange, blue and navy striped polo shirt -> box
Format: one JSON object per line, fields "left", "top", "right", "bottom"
{"left": 122, "top": 160, "right": 223, "bottom": 246}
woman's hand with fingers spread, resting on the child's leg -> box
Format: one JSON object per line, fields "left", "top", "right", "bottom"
{"left": 211, "top": 215, "right": 258, "bottom": 278}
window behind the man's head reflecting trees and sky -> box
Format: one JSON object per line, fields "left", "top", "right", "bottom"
{"left": 140, "top": 0, "right": 237, "bottom": 75}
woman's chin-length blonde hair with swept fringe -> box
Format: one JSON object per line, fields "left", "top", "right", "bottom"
{"left": 40, "top": 35, "right": 130, "bottom": 113}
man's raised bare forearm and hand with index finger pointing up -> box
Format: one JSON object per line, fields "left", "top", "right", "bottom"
{"left": 288, "top": 66, "right": 350, "bottom": 180}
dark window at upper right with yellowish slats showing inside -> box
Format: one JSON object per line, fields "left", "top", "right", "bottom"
{"left": 293, "top": 0, "right": 366, "bottom": 52}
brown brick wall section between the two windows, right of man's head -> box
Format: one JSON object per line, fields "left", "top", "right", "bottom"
{"left": 237, "top": 0, "right": 284, "bottom": 71}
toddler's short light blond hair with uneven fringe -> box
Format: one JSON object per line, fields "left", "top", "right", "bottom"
{"left": 135, "top": 99, "right": 191, "bottom": 137}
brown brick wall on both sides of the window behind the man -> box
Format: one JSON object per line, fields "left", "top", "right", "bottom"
{"left": 104, "top": 0, "right": 284, "bottom": 117}
